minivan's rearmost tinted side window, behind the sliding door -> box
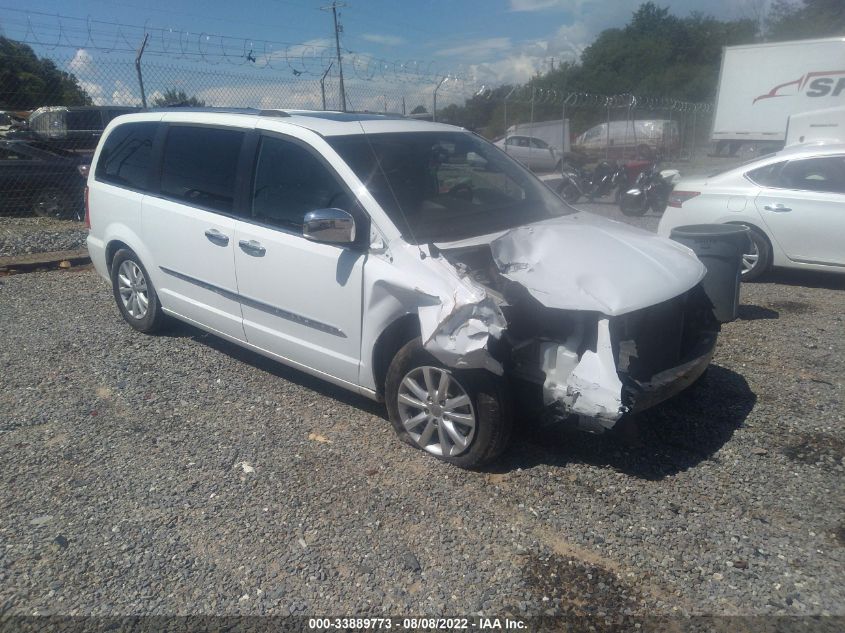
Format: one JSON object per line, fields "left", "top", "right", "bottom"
{"left": 95, "top": 121, "right": 158, "bottom": 191}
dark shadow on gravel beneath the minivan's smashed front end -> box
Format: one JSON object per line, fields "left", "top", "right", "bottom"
{"left": 490, "top": 365, "right": 757, "bottom": 481}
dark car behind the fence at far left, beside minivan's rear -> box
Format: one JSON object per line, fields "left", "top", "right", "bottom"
{"left": 0, "top": 140, "right": 90, "bottom": 220}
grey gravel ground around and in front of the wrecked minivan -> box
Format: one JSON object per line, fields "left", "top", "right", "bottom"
{"left": 0, "top": 256, "right": 845, "bottom": 616}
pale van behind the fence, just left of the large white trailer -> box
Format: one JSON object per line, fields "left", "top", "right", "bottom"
{"left": 573, "top": 119, "right": 681, "bottom": 160}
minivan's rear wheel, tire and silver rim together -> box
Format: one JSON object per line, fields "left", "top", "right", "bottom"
{"left": 111, "top": 248, "right": 165, "bottom": 334}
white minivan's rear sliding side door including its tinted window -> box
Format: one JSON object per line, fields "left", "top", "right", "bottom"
{"left": 142, "top": 124, "right": 246, "bottom": 340}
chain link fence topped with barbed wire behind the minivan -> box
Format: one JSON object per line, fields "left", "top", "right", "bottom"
{"left": 0, "top": 31, "right": 711, "bottom": 257}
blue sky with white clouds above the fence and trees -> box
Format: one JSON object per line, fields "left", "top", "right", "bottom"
{"left": 0, "top": 0, "right": 771, "bottom": 112}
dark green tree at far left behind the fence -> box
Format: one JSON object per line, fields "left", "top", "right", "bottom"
{"left": 0, "top": 36, "right": 93, "bottom": 110}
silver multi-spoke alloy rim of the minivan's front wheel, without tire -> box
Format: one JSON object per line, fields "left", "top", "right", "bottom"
{"left": 398, "top": 366, "right": 476, "bottom": 457}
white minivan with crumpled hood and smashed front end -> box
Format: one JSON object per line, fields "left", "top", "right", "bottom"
{"left": 86, "top": 109, "right": 718, "bottom": 467}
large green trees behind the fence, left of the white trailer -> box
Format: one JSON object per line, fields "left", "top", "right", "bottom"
{"left": 437, "top": 0, "right": 760, "bottom": 138}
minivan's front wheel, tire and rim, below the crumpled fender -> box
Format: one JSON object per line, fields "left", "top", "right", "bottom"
{"left": 385, "top": 338, "right": 513, "bottom": 468}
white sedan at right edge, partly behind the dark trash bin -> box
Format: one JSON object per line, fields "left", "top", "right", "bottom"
{"left": 657, "top": 144, "right": 845, "bottom": 281}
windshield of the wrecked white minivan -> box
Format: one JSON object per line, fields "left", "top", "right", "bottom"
{"left": 327, "top": 132, "right": 575, "bottom": 244}
